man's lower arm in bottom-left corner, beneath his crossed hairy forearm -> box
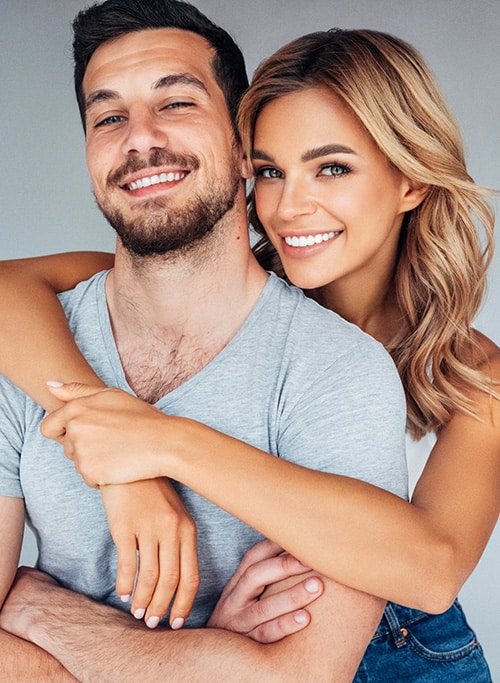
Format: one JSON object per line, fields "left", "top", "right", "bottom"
{"left": 0, "top": 630, "right": 75, "bottom": 683}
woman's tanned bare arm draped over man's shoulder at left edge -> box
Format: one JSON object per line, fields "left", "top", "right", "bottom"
{"left": 0, "top": 252, "right": 114, "bottom": 410}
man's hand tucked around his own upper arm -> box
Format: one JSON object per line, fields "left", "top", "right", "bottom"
{"left": 207, "top": 540, "right": 323, "bottom": 643}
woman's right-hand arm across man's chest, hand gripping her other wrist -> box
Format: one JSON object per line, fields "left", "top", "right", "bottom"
{"left": 43, "top": 345, "right": 500, "bottom": 612}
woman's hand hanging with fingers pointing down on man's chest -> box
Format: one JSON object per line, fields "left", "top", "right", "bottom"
{"left": 100, "top": 479, "right": 199, "bottom": 629}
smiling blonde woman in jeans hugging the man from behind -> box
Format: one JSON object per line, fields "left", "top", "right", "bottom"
{"left": 1, "top": 26, "right": 500, "bottom": 681}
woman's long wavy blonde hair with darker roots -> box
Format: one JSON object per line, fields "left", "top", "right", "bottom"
{"left": 238, "top": 29, "right": 496, "bottom": 438}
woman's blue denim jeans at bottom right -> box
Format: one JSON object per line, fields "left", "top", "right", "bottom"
{"left": 354, "top": 602, "right": 492, "bottom": 683}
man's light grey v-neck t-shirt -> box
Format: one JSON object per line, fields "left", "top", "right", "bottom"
{"left": 0, "top": 273, "right": 407, "bottom": 627}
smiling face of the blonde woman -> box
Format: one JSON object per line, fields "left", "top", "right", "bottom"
{"left": 253, "top": 87, "right": 414, "bottom": 289}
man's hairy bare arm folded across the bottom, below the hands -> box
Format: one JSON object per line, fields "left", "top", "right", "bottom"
{"left": 0, "top": 570, "right": 383, "bottom": 683}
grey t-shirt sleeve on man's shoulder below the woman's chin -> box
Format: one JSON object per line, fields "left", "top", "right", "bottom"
{"left": 278, "top": 337, "right": 408, "bottom": 498}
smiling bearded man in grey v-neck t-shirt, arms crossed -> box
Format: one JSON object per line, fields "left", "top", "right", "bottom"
{"left": 0, "top": 0, "right": 406, "bottom": 681}
